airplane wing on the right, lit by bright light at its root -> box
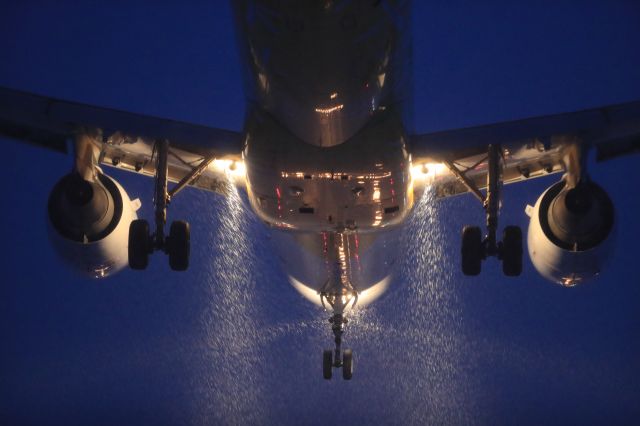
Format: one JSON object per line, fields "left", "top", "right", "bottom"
{"left": 410, "top": 101, "right": 640, "bottom": 197}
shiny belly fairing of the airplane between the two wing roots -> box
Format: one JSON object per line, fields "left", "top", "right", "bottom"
{"left": 243, "top": 106, "right": 413, "bottom": 233}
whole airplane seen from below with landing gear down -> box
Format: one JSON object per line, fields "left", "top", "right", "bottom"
{"left": 0, "top": 0, "right": 640, "bottom": 380}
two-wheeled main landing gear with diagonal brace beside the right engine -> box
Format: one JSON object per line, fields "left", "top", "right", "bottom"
{"left": 448, "top": 145, "right": 522, "bottom": 277}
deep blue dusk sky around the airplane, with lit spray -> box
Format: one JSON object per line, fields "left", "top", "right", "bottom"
{"left": 0, "top": 1, "right": 640, "bottom": 424}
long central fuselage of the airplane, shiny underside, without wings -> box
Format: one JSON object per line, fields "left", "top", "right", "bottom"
{"left": 233, "top": 0, "right": 414, "bottom": 303}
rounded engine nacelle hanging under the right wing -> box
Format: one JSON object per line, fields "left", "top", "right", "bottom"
{"left": 527, "top": 180, "right": 615, "bottom": 287}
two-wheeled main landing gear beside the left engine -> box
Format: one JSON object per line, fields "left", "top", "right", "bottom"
{"left": 129, "top": 140, "right": 190, "bottom": 271}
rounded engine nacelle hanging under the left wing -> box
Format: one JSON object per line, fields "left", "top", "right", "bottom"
{"left": 48, "top": 173, "right": 140, "bottom": 278}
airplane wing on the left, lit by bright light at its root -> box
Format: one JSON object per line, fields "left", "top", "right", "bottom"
{"left": 0, "top": 87, "right": 243, "bottom": 193}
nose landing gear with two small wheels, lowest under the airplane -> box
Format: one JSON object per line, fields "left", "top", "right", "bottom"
{"left": 320, "top": 292, "right": 358, "bottom": 380}
